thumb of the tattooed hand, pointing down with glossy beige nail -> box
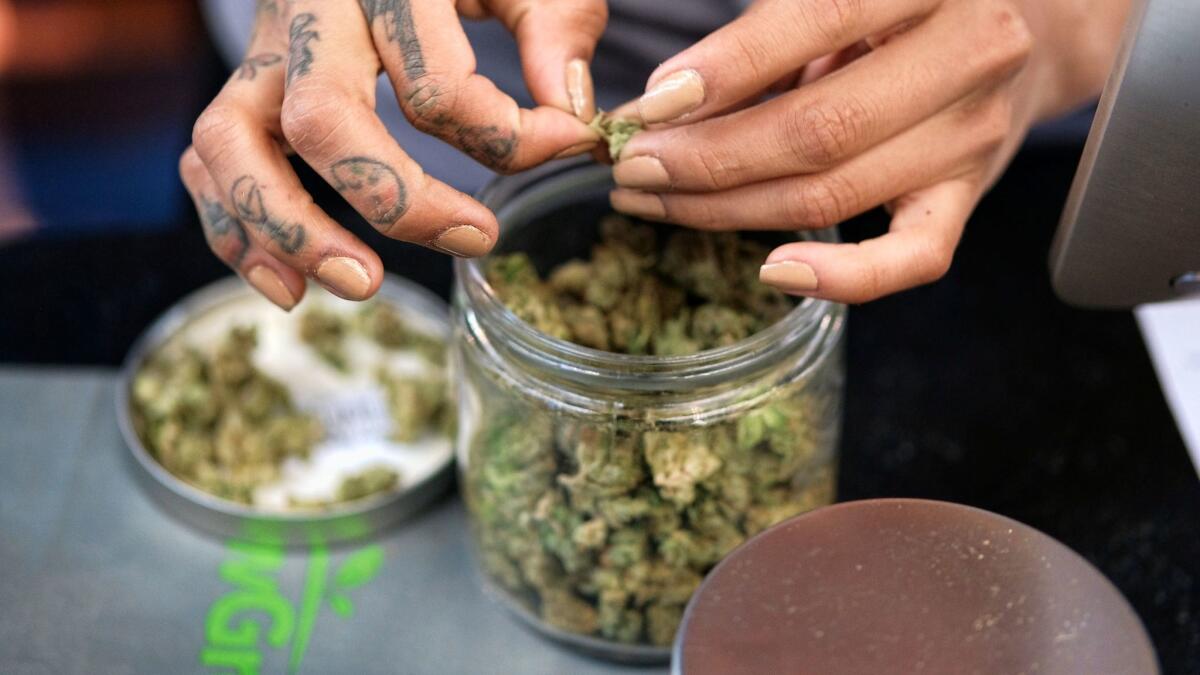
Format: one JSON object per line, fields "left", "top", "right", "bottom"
{"left": 491, "top": 0, "right": 608, "bottom": 123}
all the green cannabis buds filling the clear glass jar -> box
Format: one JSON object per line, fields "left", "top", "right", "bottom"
{"left": 463, "top": 215, "right": 836, "bottom": 645}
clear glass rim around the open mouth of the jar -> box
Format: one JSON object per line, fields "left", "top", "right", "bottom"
{"left": 455, "top": 159, "right": 845, "bottom": 389}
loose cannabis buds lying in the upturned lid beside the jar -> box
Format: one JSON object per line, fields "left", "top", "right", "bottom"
{"left": 132, "top": 301, "right": 454, "bottom": 508}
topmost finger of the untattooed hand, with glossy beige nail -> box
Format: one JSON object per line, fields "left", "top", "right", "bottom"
{"left": 637, "top": 0, "right": 942, "bottom": 124}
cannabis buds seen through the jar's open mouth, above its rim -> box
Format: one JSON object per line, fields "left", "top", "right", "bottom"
{"left": 485, "top": 215, "right": 793, "bottom": 356}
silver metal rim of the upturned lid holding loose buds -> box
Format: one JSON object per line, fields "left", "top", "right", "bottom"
{"left": 116, "top": 275, "right": 454, "bottom": 545}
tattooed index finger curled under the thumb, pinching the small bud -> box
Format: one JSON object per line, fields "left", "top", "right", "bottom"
{"left": 360, "top": 0, "right": 598, "bottom": 172}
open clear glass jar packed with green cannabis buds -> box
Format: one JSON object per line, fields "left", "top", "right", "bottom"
{"left": 454, "top": 162, "right": 846, "bottom": 662}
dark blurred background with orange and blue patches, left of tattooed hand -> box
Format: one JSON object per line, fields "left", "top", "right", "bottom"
{"left": 0, "top": 0, "right": 248, "bottom": 364}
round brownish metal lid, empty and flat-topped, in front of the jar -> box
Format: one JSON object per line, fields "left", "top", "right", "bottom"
{"left": 673, "top": 500, "right": 1158, "bottom": 675}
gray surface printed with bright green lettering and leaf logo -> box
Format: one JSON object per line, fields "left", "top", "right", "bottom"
{"left": 0, "top": 369, "right": 666, "bottom": 675}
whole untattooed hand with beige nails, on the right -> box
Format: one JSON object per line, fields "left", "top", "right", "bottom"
{"left": 611, "top": 0, "right": 1129, "bottom": 303}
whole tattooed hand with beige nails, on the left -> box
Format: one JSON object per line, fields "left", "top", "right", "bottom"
{"left": 180, "top": 0, "right": 607, "bottom": 309}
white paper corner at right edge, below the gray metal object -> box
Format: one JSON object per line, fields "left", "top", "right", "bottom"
{"left": 1134, "top": 298, "right": 1200, "bottom": 472}
